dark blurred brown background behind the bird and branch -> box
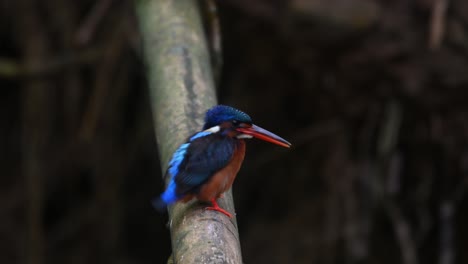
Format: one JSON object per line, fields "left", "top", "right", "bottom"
{"left": 0, "top": 0, "right": 468, "bottom": 264}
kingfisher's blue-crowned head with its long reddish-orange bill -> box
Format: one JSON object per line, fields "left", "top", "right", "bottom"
{"left": 203, "top": 105, "right": 291, "bottom": 148}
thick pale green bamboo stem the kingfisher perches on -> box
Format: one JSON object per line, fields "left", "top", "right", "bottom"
{"left": 137, "top": 0, "right": 242, "bottom": 263}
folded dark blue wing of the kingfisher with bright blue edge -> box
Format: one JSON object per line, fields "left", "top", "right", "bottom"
{"left": 161, "top": 130, "right": 237, "bottom": 204}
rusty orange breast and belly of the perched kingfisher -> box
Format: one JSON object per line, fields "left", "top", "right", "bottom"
{"left": 195, "top": 140, "right": 245, "bottom": 201}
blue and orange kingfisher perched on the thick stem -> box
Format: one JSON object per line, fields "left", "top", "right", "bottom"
{"left": 152, "top": 105, "right": 291, "bottom": 218}
